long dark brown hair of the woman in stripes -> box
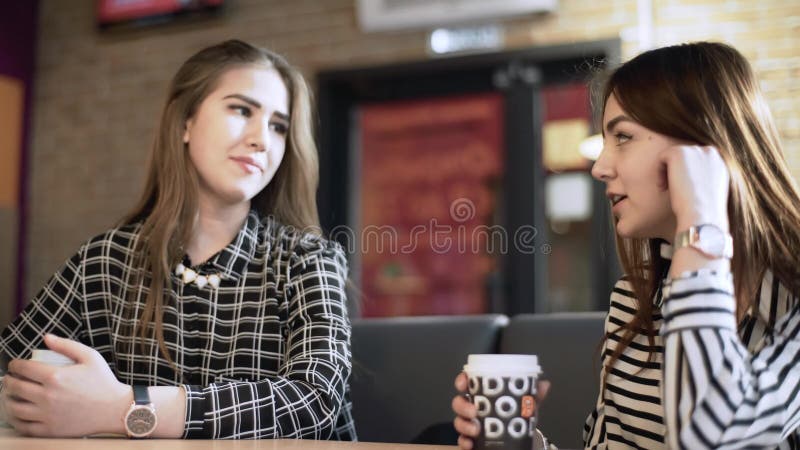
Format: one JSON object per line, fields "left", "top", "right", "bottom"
{"left": 601, "top": 42, "right": 800, "bottom": 375}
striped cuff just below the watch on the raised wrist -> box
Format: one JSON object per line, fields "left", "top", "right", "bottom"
{"left": 661, "top": 271, "right": 736, "bottom": 335}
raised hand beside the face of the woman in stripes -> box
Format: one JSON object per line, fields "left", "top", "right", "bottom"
{"left": 660, "top": 145, "right": 730, "bottom": 233}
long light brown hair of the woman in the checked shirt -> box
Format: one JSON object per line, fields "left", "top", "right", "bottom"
{"left": 121, "top": 40, "right": 319, "bottom": 367}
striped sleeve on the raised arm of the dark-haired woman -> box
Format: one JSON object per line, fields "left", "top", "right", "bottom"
{"left": 661, "top": 273, "right": 800, "bottom": 449}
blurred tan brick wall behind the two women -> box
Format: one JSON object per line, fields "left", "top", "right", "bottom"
{"left": 20, "top": 0, "right": 800, "bottom": 306}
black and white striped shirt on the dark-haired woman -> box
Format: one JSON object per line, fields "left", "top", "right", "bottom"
{"left": 584, "top": 249, "right": 800, "bottom": 450}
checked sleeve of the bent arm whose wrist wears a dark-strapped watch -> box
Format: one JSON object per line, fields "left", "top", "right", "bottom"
{"left": 184, "top": 239, "right": 351, "bottom": 439}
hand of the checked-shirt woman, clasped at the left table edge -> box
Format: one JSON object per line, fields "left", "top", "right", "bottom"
{"left": 4, "top": 335, "right": 133, "bottom": 437}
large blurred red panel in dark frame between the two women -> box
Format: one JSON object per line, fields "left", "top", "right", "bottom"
{"left": 360, "top": 94, "right": 503, "bottom": 317}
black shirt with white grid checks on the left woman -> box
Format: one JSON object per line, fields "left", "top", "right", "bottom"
{"left": 0, "top": 211, "right": 355, "bottom": 440}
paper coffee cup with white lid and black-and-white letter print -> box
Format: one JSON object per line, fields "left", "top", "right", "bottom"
{"left": 464, "top": 354, "right": 542, "bottom": 450}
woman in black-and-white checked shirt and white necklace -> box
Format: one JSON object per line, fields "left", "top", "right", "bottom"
{"left": 0, "top": 40, "right": 355, "bottom": 439}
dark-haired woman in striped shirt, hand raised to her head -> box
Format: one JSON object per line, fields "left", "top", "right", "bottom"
{"left": 453, "top": 42, "right": 800, "bottom": 449}
